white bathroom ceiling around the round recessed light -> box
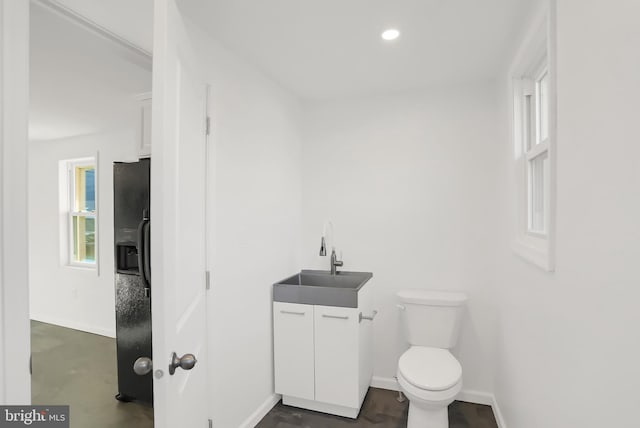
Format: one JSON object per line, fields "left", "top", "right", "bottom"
{"left": 180, "top": 0, "right": 538, "bottom": 100}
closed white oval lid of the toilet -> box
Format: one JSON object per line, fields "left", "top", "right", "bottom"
{"left": 398, "top": 346, "right": 462, "bottom": 391}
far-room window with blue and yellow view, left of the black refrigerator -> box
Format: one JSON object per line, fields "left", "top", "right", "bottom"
{"left": 66, "top": 158, "right": 97, "bottom": 267}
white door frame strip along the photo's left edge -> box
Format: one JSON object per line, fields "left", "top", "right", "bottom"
{"left": 0, "top": 0, "right": 31, "bottom": 404}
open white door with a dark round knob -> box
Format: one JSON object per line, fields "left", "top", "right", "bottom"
{"left": 151, "top": 0, "right": 208, "bottom": 428}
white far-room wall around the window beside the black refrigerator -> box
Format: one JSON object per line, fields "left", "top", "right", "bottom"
{"left": 29, "top": 131, "right": 137, "bottom": 337}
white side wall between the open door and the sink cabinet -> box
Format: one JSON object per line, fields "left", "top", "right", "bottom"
{"left": 185, "top": 25, "right": 301, "bottom": 427}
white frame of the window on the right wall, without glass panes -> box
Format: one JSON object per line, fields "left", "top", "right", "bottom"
{"left": 509, "top": 10, "right": 557, "bottom": 272}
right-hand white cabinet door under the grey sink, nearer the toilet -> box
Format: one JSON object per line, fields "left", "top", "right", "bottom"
{"left": 315, "top": 306, "right": 360, "bottom": 407}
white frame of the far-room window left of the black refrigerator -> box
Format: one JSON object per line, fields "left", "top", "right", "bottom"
{"left": 64, "top": 156, "right": 99, "bottom": 270}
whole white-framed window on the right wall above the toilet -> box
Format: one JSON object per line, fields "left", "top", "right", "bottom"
{"left": 511, "top": 18, "right": 556, "bottom": 271}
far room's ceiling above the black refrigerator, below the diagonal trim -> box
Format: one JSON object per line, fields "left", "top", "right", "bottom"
{"left": 29, "top": 2, "right": 151, "bottom": 141}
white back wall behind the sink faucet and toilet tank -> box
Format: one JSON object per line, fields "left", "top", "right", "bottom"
{"left": 302, "top": 83, "right": 502, "bottom": 400}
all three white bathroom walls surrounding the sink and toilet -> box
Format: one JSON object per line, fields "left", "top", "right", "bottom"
{"left": 179, "top": 0, "right": 640, "bottom": 428}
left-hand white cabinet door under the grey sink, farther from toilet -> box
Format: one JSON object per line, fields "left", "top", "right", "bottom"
{"left": 273, "top": 302, "right": 314, "bottom": 400}
